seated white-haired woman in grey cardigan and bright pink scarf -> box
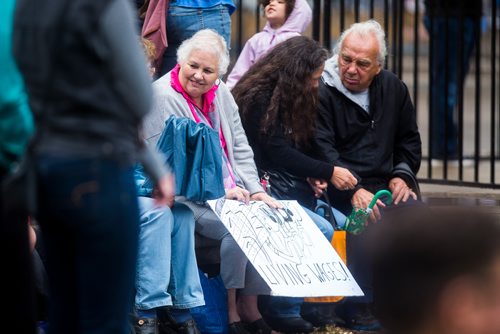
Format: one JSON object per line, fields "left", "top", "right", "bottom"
{"left": 144, "top": 29, "right": 280, "bottom": 333}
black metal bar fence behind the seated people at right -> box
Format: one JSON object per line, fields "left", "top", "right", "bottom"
{"left": 232, "top": 0, "right": 500, "bottom": 188}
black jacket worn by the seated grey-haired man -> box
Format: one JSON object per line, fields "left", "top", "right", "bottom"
{"left": 316, "top": 70, "right": 422, "bottom": 204}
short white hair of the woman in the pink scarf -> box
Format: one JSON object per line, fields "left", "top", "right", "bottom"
{"left": 177, "top": 29, "right": 229, "bottom": 76}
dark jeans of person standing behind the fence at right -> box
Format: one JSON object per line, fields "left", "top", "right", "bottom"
{"left": 424, "top": 16, "right": 476, "bottom": 159}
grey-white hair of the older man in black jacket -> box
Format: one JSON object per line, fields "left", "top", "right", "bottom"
{"left": 333, "top": 20, "right": 387, "bottom": 66}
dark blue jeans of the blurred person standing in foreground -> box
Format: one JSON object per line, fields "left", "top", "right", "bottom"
{"left": 37, "top": 155, "right": 139, "bottom": 334}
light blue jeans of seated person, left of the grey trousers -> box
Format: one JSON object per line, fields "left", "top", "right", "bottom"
{"left": 135, "top": 197, "right": 205, "bottom": 310}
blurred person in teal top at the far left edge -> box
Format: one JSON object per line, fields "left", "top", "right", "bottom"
{"left": 0, "top": 0, "right": 35, "bottom": 333}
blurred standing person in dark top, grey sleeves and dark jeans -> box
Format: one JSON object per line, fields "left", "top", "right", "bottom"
{"left": 13, "top": 0, "right": 173, "bottom": 334}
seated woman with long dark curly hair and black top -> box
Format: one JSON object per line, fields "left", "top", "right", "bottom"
{"left": 232, "top": 36, "right": 357, "bottom": 332}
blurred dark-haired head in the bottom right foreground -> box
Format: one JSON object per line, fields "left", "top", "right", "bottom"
{"left": 368, "top": 207, "right": 500, "bottom": 334}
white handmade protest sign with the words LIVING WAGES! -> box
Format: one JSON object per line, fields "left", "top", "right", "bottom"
{"left": 208, "top": 199, "right": 363, "bottom": 297}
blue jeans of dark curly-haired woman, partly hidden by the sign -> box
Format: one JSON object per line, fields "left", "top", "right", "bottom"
{"left": 265, "top": 206, "right": 333, "bottom": 318}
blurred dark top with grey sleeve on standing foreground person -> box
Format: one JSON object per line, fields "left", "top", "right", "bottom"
{"left": 13, "top": 0, "right": 152, "bottom": 161}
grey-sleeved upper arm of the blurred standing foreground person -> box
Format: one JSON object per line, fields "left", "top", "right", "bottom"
{"left": 98, "top": 0, "right": 152, "bottom": 119}
